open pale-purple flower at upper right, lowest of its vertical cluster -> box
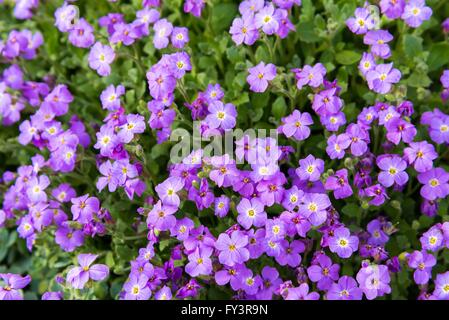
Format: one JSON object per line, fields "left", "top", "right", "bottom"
{"left": 366, "top": 63, "right": 401, "bottom": 94}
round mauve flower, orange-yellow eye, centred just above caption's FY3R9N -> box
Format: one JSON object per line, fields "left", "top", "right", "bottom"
{"left": 215, "top": 231, "right": 249, "bottom": 267}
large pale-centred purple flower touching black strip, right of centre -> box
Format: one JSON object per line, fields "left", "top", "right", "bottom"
{"left": 356, "top": 265, "right": 391, "bottom": 300}
